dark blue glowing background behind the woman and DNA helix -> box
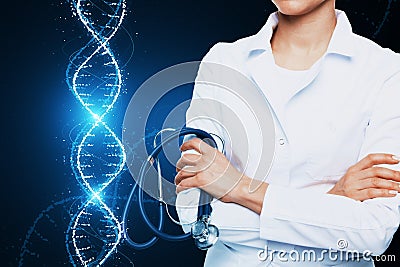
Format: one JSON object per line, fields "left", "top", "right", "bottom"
{"left": 0, "top": 0, "right": 400, "bottom": 266}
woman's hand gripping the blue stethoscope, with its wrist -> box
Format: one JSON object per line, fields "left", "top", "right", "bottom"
{"left": 175, "top": 138, "right": 268, "bottom": 213}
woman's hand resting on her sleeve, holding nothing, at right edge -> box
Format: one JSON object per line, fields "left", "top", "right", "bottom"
{"left": 328, "top": 154, "right": 400, "bottom": 201}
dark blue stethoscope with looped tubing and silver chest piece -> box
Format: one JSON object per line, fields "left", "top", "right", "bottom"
{"left": 122, "top": 127, "right": 219, "bottom": 250}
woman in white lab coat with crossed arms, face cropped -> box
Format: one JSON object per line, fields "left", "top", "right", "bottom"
{"left": 175, "top": 0, "right": 400, "bottom": 267}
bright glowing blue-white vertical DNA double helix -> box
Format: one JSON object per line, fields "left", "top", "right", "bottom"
{"left": 66, "top": 0, "right": 126, "bottom": 266}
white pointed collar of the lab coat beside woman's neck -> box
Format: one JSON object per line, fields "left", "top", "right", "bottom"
{"left": 249, "top": 10, "right": 355, "bottom": 57}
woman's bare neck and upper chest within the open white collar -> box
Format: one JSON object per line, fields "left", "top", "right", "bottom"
{"left": 271, "top": 1, "right": 336, "bottom": 70}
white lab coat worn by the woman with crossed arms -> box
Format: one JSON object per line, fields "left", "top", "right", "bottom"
{"left": 178, "top": 11, "right": 400, "bottom": 267}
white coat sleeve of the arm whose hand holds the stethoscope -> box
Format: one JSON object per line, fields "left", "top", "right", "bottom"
{"left": 260, "top": 72, "right": 400, "bottom": 255}
